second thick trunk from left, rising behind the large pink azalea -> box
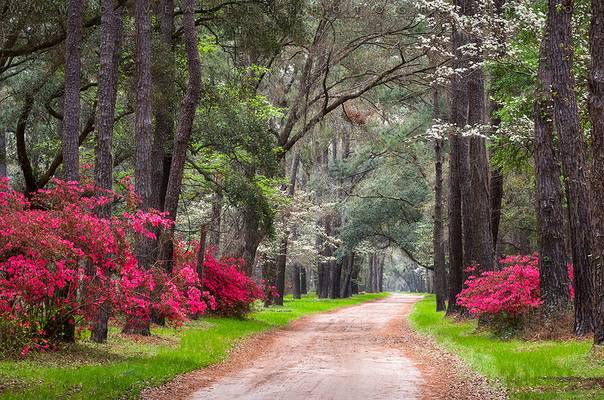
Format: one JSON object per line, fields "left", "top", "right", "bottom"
{"left": 91, "top": 0, "right": 123, "bottom": 343}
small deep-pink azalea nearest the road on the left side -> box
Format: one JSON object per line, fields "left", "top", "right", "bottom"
{"left": 174, "top": 243, "right": 264, "bottom": 317}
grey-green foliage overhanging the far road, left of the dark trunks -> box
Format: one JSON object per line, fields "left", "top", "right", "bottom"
{"left": 341, "top": 112, "right": 432, "bottom": 251}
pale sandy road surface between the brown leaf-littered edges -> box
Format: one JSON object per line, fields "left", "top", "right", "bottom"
{"left": 193, "top": 294, "right": 423, "bottom": 400}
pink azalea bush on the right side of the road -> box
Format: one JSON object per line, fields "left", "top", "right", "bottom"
{"left": 457, "top": 254, "right": 574, "bottom": 316}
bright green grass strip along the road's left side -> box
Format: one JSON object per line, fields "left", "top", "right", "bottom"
{"left": 0, "top": 293, "right": 387, "bottom": 399}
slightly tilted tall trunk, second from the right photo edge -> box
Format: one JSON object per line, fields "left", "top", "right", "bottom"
{"left": 546, "top": 0, "right": 594, "bottom": 335}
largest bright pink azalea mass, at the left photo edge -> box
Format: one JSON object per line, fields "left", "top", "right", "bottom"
{"left": 0, "top": 179, "right": 206, "bottom": 356}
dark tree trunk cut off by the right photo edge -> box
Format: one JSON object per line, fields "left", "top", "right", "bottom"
{"left": 589, "top": 0, "right": 604, "bottom": 345}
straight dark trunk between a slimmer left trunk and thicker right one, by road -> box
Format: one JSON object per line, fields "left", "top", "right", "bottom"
{"left": 447, "top": 5, "right": 468, "bottom": 314}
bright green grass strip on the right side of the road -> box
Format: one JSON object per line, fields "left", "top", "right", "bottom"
{"left": 410, "top": 296, "right": 604, "bottom": 399}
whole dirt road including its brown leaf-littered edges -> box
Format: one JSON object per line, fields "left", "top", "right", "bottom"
{"left": 143, "top": 294, "right": 505, "bottom": 400}
